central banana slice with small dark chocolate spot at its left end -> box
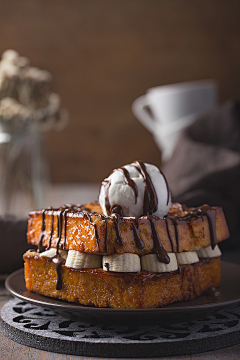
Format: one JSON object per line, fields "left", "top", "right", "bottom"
{"left": 102, "top": 253, "right": 141, "bottom": 272}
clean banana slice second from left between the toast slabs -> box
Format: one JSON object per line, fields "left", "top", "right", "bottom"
{"left": 65, "top": 250, "right": 102, "bottom": 269}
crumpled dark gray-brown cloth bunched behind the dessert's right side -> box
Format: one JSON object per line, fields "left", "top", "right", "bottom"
{"left": 162, "top": 101, "right": 240, "bottom": 248}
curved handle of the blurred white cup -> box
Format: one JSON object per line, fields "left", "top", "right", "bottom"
{"left": 132, "top": 95, "right": 156, "bottom": 134}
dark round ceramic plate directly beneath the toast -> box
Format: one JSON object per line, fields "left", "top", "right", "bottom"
{"left": 5, "top": 261, "right": 240, "bottom": 325}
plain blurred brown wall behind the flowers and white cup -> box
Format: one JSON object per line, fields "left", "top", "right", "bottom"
{"left": 0, "top": 0, "right": 240, "bottom": 182}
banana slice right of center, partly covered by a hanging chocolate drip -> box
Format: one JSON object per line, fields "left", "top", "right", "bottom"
{"left": 141, "top": 253, "right": 178, "bottom": 273}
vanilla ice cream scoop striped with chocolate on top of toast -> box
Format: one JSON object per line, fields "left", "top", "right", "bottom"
{"left": 99, "top": 161, "right": 171, "bottom": 217}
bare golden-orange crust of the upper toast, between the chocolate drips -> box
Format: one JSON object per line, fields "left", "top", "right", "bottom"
{"left": 27, "top": 204, "right": 229, "bottom": 255}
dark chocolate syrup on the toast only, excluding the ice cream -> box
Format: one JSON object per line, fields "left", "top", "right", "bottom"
{"left": 38, "top": 205, "right": 217, "bottom": 290}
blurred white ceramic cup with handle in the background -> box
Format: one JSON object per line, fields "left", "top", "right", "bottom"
{"left": 132, "top": 80, "right": 218, "bottom": 161}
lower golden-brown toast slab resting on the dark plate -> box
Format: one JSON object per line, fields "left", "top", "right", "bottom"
{"left": 24, "top": 255, "right": 221, "bottom": 309}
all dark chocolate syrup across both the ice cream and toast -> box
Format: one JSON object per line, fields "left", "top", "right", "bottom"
{"left": 38, "top": 161, "right": 217, "bottom": 290}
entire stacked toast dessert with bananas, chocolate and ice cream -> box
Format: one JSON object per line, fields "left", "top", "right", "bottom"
{"left": 23, "top": 161, "right": 229, "bottom": 309}
